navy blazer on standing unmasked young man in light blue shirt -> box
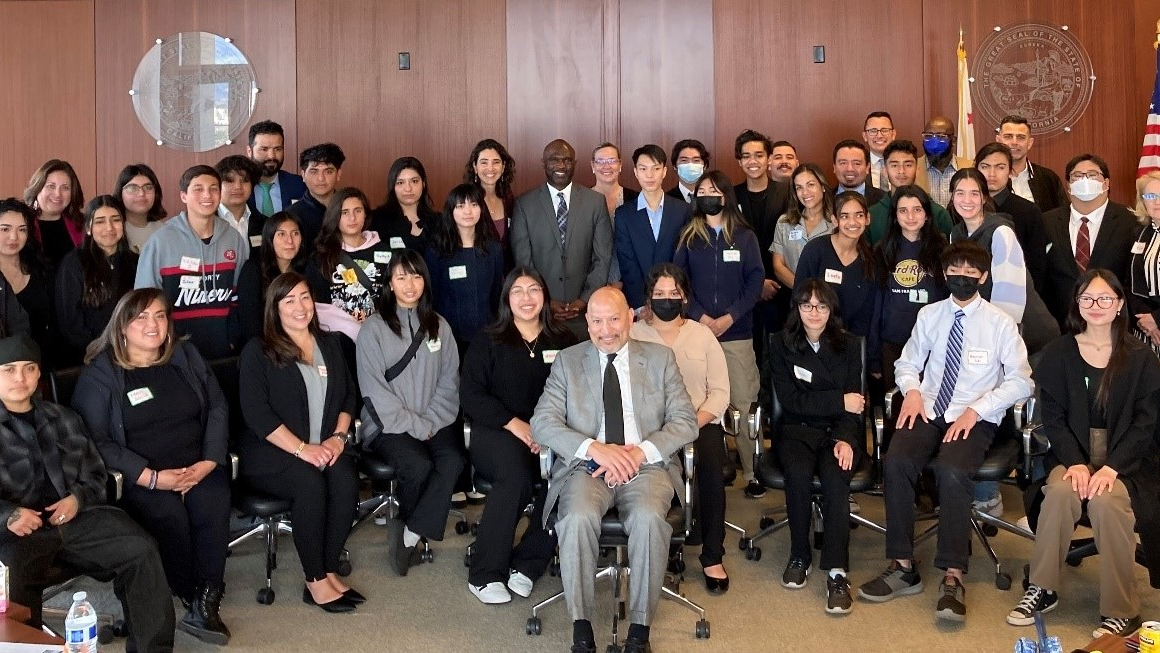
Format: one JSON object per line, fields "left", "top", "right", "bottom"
{"left": 614, "top": 195, "right": 691, "bottom": 309}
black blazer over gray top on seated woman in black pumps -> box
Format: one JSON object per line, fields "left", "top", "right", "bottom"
{"left": 238, "top": 332, "right": 357, "bottom": 474}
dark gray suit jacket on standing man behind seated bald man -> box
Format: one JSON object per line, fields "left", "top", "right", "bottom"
{"left": 508, "top": 182, "right": 612, "bottom": 302}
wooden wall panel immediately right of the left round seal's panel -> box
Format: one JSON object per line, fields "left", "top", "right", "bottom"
{"left": 297, "top": 0, "right": 508, "bottom": 208}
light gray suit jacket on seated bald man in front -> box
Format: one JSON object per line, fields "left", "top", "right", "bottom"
{"left": 531, "top": 340, "right": 697, "bottom": 518}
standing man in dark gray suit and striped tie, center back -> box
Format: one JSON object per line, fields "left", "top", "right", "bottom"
{"left": 509, "top": 139, "right": 612, "bottom": 338}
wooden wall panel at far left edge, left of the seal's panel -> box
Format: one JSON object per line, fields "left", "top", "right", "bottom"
{"left": 0, "top": 0, "right": 99, "bottom": 197}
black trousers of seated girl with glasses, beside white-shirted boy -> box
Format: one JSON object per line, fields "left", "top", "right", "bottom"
{"left": 777, "top": 425, "right": 862, "bottom": 569}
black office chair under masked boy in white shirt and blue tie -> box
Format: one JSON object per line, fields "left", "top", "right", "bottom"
{"left": 875, "top": 387, "right": 1035, "bottom": 590}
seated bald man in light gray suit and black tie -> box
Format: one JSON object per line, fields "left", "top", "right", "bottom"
{"left": 531, "top": 288, "right": 697, "bottom": 653}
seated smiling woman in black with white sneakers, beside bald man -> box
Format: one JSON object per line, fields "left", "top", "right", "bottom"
{"left": 459, "top": 268, "right": 577, "bottom": 603}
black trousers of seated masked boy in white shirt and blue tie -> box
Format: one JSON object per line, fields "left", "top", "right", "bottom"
{"left": 883, "top": 418, "right": 998, "bottom": 572}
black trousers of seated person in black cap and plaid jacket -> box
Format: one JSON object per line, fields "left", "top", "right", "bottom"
{"left": 0, "top": 506, "right": 174, "bottom": 653}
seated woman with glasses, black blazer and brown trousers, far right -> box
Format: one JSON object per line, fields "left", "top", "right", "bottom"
{"left": 1007, "top": 268, "right": 1160, "bottom": 637}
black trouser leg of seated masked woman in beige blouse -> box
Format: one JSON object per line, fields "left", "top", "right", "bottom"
{"left": 693, "top": 423, "right": 726, "bottom": 567}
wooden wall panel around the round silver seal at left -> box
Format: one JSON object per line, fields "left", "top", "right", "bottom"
{"left": 96, "top": 0, "right": 297, "bottom": 215}
